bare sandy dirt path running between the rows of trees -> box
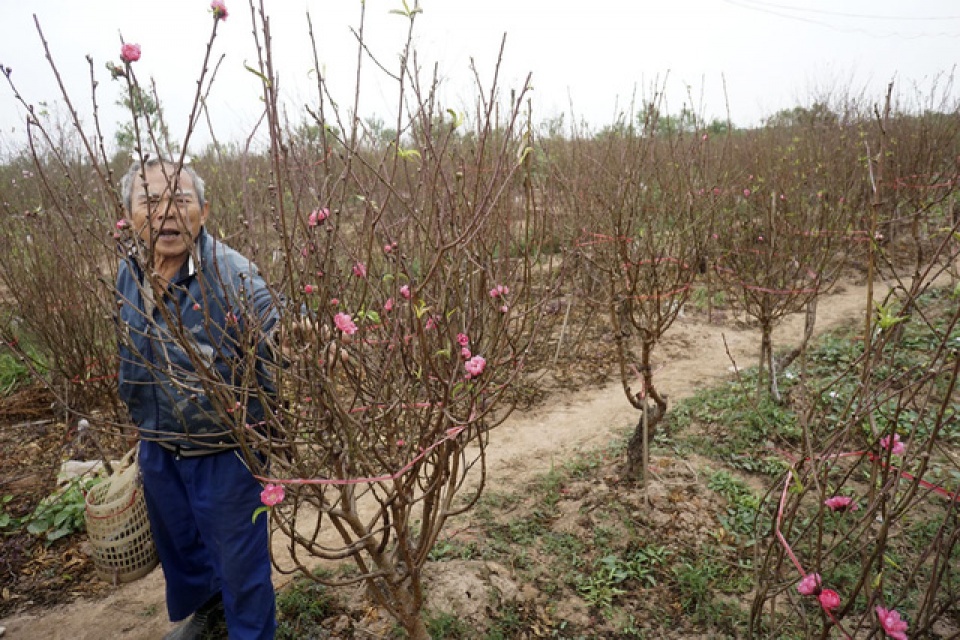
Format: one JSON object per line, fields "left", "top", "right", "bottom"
{"left": 0, "top": 284, "right": 886, "bottom": 640}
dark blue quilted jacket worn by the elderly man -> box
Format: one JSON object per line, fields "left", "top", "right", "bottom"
{"left": 117, "top": 230, "right": 278, "bottom": 449}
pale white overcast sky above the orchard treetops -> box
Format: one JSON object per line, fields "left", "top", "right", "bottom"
{"left": 0, "top": 0, "right": 960, "bottom": 151}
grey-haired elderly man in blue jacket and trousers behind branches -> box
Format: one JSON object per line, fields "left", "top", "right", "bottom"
{"left": 117, "top": 159, "right": 277, "bottom": 640}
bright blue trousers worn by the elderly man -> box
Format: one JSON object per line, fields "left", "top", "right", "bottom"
{"left": 138, "top": 440, "right": 276, "bottom": 640}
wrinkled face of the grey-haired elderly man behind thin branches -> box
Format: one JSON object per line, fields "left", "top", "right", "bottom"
{"left": 130, "top": 164, "right": 209, "bottom": 265}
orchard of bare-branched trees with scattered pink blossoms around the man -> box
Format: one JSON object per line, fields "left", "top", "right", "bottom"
{"left": 0, "top": 2, "right": 960, "bottom": 640}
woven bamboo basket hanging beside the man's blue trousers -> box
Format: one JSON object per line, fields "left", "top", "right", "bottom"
{"left": 84, "top": 447, "right": 159, "bottom": 584}
